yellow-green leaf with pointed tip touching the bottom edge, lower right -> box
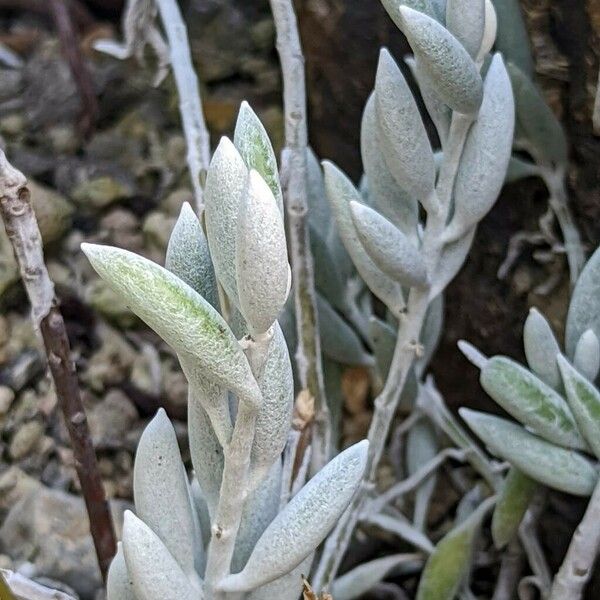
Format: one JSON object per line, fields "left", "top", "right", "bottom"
{"left": 416, "top": 499, "right": 493, "bottom": 600}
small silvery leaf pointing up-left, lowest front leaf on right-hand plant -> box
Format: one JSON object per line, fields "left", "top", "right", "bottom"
{"left": 350, "top": 201, "right": 428, "bottom": 287}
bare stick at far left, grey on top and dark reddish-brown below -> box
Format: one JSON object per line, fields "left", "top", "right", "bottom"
{"left": 0, "top": 150, "right": 116, "bottom": 577}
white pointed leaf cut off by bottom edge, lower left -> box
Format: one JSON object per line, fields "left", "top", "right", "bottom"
{"left": 123, "top": 511, "right": 204, "bottom": 600}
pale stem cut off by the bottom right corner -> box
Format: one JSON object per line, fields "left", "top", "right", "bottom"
{"left": 549, "top": 482, "right": 600, "bottom": 600}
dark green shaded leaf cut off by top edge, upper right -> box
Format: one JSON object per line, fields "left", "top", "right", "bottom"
{"left": 493, "top": 0, "right": 535, "bottom": 77}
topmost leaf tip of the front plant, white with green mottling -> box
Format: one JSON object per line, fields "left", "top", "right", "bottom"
{"left": 233, "top": 100, "right": 283, "bottom": 217}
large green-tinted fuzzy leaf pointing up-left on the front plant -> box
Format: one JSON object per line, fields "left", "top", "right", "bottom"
{"left": 81, "top": 244, "right": 260, "bottom": 404}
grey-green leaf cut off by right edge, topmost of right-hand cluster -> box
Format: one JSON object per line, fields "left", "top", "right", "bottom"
{"left": 565, "top": 248, "right": 600, "bottom": 358}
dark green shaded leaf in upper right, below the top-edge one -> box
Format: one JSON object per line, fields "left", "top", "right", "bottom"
{"left": 508, "top": 63, "right": 567, "bottom": 166}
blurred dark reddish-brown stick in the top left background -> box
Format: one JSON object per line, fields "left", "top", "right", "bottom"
{"left": 50, "top": 0, "right": 99, "bottom": 135}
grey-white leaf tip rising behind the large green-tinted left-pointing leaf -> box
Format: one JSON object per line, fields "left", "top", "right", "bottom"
{"left": 165, "top": 202, "right": 219, "bottom": 310}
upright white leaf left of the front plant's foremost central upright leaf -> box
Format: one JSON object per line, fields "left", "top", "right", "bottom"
{"left": 204, "top": 137, "right": 248, "bottom": 306}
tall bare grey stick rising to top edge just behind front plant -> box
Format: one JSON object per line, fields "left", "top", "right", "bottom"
{"left": 271, "top": 0, "right": 331, "bottom": 473}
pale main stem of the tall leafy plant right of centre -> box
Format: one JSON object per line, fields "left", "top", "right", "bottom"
{"left": 313, "top": 113, "right": 473, "bottom": 590}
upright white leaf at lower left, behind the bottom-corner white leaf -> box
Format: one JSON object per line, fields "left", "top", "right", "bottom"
{"left": 133, "top": 408, "right": 197, "bottom": 574}
